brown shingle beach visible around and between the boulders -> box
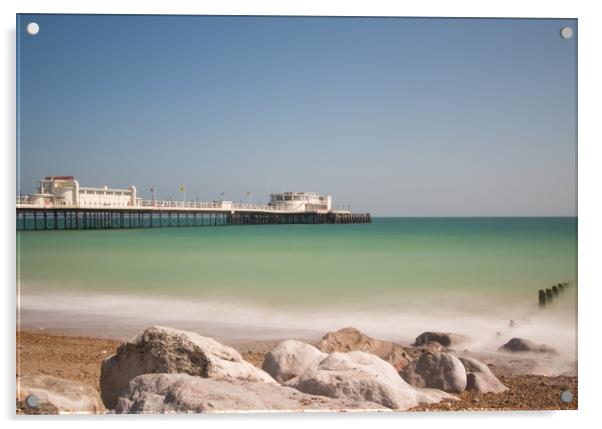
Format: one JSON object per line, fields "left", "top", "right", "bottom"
{"left": 17, "top": 330, "right": 578, "bottom": 412}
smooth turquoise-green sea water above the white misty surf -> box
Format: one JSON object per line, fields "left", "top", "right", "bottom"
{"left": 17, "top": 218, "right": 577, "bottom": 307}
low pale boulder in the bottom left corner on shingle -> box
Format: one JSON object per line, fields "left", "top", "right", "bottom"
{"left": 17, "top": 375, "right": 106, "bottom": 414}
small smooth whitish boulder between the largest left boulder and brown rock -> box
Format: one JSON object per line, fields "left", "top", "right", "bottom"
{"left": 261, "top": 340, "right": 328, "bottom": 383}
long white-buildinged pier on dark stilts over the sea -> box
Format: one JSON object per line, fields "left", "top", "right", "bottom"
{"left": 16, "top": 176, "right": 372, "bottom": 231}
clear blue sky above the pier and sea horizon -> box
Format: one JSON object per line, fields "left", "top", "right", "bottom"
{"left": 17, "top": 14, "right": 577, "bottom": 216}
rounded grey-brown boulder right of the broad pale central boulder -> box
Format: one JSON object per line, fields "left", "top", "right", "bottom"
{"left": 401, "top": 352, "right": 467, "bottom": 393}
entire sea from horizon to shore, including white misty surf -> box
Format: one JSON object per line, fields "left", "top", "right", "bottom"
{"left": 17, "top": 217, "right": 577, "bottom": 353}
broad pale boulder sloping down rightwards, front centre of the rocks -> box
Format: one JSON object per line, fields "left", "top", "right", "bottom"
{"left": 284, "top": 351, "right": 453, "bottom": 410}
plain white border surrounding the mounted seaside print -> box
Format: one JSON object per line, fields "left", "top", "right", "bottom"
{"left": 0, "top": 0, "right": 602, "bottom": 429}
